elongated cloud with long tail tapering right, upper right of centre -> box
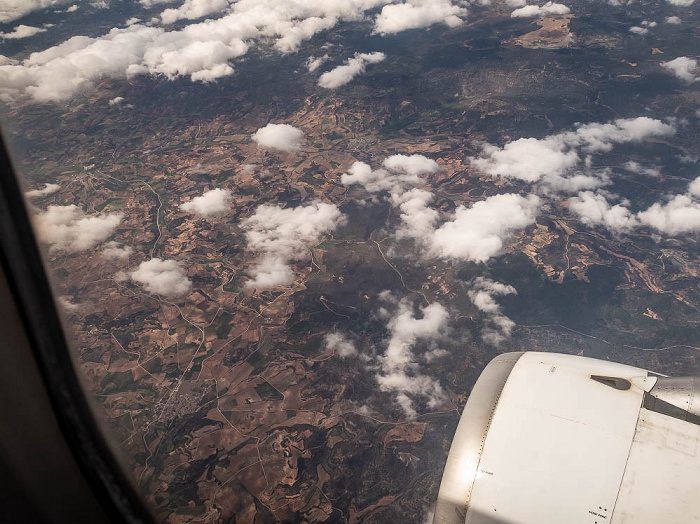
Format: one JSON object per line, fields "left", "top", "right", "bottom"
{"left": 471, "top": 117, "right": 675, "bottom": 192}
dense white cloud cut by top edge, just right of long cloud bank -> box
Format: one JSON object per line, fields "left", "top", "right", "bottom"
{"left": 374, "top": 0, "right": 467, "bottom": 35}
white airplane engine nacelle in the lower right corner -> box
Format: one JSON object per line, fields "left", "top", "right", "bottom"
{"left": 433, "top": 352, "right": 700, "bottom": 524}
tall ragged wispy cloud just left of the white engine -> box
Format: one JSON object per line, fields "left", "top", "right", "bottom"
{"left": 377, "top": 293, "right": 449, "bottom": 418}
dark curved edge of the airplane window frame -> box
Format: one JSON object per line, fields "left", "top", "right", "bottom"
{"left": 0, "top": 132, "right": 155, "bottom": 524}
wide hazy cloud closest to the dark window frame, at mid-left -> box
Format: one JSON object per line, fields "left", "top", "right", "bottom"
{"left": 35, "top": 204, "right": 124, "bottom": 253}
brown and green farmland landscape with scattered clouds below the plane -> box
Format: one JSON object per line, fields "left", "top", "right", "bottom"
{"left": 0, "top": 0, "right": 700, "bottom": 524}
